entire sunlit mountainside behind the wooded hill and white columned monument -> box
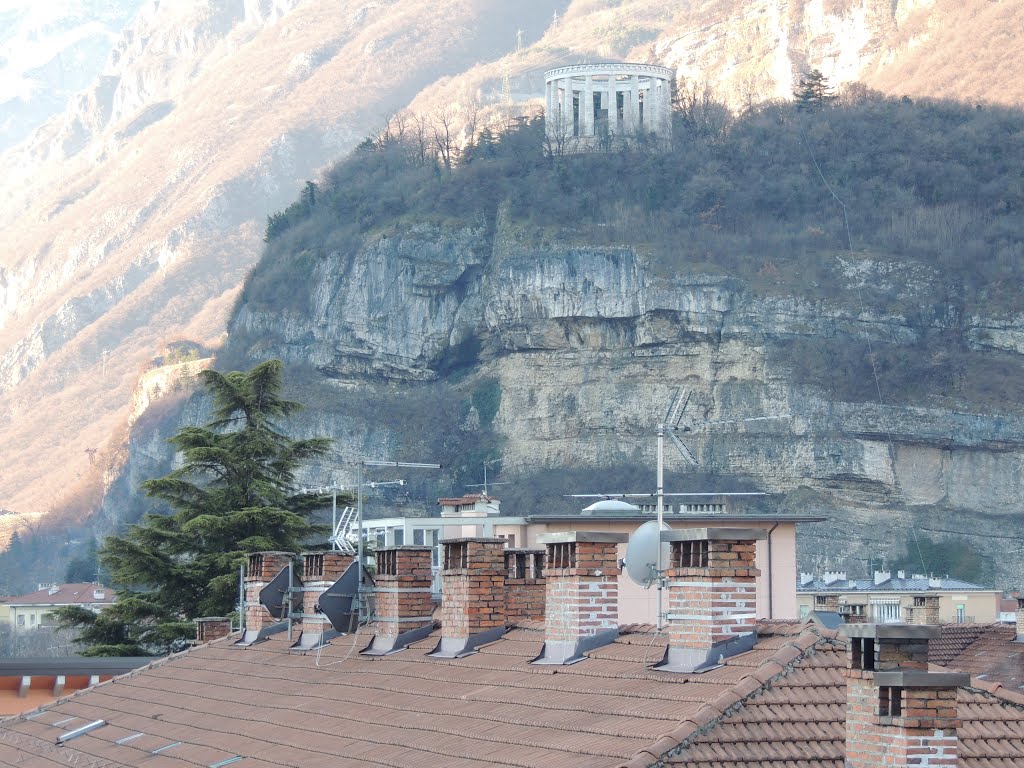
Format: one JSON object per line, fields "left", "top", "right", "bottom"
{"left": 0, "top": 0, "right": 1024, "bottom": 536}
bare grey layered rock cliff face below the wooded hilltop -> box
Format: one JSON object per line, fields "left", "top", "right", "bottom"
{"left": 228, "top": 214, "right": 1024, "bottom": 586}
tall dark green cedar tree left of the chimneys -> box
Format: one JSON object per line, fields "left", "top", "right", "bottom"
{"left": 58, "top": 360, "right": 330, "bottom": 656}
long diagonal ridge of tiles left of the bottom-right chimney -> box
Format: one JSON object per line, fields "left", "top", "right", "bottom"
{"left": 618, "top": 627, "right": 838, "bottom": 768}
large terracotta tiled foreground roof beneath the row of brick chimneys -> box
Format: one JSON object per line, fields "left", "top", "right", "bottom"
{"left": 0, "top": 622, "right": 1024, "bottom": 768}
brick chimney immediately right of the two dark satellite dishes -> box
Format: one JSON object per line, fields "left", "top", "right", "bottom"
{"left": 360, "top": 547, "right": 434, "bottom": 656}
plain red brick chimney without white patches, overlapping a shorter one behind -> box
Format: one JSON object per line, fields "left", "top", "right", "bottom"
{"left": 430, "top": 538, "right": 505, "bottom": 658}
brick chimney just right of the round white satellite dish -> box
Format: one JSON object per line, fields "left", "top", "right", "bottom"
{"left": 655, "top": 528, "right": 768, "bottom": 673}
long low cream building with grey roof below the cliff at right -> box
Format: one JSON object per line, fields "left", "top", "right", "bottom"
{"left": 797, "top": 570, "right": 1002, "bottom": 624}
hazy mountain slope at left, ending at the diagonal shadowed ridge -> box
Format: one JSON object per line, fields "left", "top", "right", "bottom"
{"left": 0, "top": 2, "right": 552, "bottom": 524}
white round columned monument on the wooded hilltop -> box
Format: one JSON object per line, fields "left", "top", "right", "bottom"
{"left": 544, "top": 62, "right": 675, "bottom": 153}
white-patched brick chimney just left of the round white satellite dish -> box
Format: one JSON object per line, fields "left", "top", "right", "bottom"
{"left": 534, "top": 530, "right": 629, "bottom": 665}
